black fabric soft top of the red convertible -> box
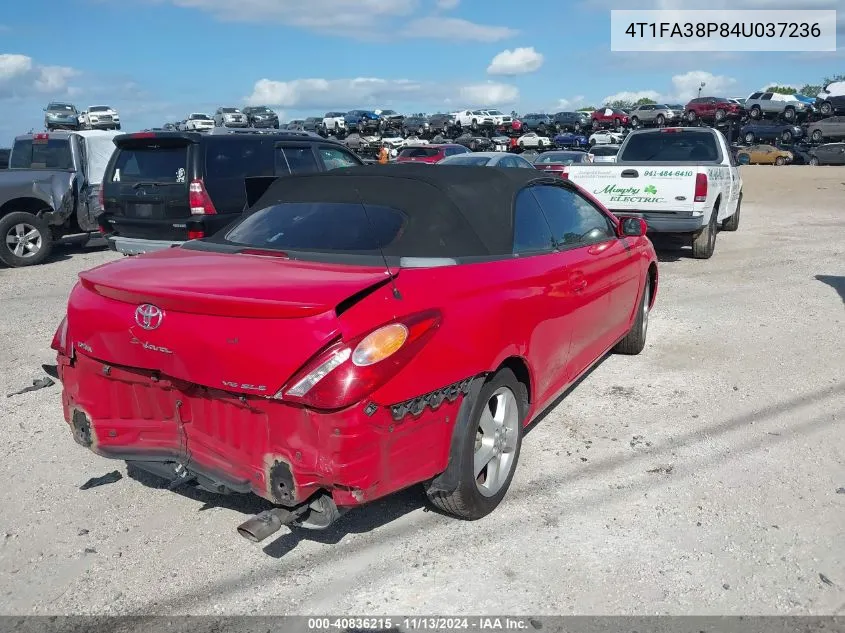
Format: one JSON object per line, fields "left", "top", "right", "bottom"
{"left": 251, "top": 164, "right": 560, "bottom": 257}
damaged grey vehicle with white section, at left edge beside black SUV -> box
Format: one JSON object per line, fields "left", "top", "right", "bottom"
{"left": 0, "top": 130, "right": 116, "bottom": 267}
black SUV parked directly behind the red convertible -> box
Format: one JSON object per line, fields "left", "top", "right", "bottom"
{"left": 98, "top": 132, "right": 363, "bottom": 255}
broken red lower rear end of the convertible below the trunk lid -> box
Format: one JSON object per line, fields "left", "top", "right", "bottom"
{"left": 59, "top": 354, "right": 463, "bottom": 507}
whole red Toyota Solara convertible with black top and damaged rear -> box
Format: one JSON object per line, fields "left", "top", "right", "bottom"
{"left": 52, "top": 165, "right": 658, "bottom": 540}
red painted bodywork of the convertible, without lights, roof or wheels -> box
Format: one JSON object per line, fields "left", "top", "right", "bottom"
{"left": 53, "top": 170, "right": 657, "bottom": 506}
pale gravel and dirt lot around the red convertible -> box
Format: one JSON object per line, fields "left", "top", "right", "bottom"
{"left": 0, "top": 167, "right": 845, "bottom": 615}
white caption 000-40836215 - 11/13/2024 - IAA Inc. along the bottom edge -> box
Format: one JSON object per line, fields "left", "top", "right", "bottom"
{"left": 308, "top": 616, "right": 542, "bottom": 633}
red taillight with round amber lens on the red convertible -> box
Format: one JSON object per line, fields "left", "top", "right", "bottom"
{"left": 274, "top": 311, "right": 440, "bottom": 410}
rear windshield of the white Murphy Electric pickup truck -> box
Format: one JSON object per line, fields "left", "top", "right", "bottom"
{"left": 619, "top": 131, "right": 719, "bottom": 162}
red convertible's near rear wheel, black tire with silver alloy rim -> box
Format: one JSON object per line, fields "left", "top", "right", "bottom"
{"left": 425, "top": 369, "right": 528, "bottom": 521}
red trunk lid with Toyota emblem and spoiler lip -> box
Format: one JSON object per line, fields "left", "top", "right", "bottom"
{"left": 68, "top": 248, "right": 386, "bottom": 395}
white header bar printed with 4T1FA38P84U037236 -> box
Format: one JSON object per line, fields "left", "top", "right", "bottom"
{"left": 610, "top": 10, "right": 836, "bottom": 53}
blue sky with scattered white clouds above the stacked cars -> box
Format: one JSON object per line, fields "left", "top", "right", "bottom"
{"left": 0, "top": 0, "right": 845, "bottom": 146}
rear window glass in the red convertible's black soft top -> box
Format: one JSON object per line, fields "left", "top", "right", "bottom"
{"left": 226, "top": 202, "right": 405, "bottom": 253}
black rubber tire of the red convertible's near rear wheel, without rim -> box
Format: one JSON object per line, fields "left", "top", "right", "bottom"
{"left": 426, "top": 369, "right": 528, "bottom": 521}
